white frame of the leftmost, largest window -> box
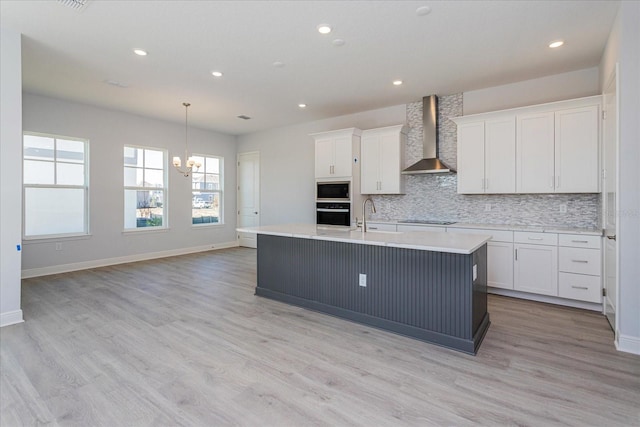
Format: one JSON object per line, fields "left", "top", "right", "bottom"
{"left": 20, "top": 131, "right": 91, "bottom": 241}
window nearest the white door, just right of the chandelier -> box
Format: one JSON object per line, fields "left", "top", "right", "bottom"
{"left": 191, "top": 155, "right": 223, "bottom": 224}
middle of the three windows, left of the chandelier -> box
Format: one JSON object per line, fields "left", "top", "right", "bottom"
{"left": 124, "top": 147, "right": 167, "bottom": 230}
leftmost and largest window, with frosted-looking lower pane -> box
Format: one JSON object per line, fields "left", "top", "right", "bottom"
{"left": 22, "top": 133, "right": 89, "bottom": 238}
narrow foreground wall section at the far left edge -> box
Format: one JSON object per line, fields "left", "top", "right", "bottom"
{"left": 0, "top": 28, "right": 22, "bottom": 326}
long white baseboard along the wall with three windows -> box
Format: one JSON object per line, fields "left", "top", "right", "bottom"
{"left": 22, "top": 240, "right": 238, "bottom": 279}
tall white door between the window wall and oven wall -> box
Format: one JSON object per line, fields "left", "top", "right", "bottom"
{"left": 238, "top": 151, "right": 260, "bottom": 248}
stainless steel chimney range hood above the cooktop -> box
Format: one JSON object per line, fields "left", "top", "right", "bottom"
{"left": 402, "top": 95, "right": 455, "bottom": 175}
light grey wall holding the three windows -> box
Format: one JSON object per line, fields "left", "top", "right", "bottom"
{"left": 21, "top": 93, "right": 236, "bottom": 277}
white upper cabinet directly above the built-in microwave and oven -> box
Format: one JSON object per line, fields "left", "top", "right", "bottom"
{"left": 310, "top": 128, "right": 362, "bottom": 178}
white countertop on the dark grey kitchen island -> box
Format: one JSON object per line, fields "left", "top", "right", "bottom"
{"left": 237, "top": 224, "right": 491, "bottom": 254}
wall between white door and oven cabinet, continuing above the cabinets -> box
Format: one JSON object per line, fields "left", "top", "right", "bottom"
{"left": 238, "top": 105, "right": 406, "bottom": 225}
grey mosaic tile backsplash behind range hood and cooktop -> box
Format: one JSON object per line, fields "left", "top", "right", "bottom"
{"left": 371, "top": 94, "right": 601, "bottom": 228}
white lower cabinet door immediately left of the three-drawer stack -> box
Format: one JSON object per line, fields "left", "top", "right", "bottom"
{"left": 513, "top": 244, "right": 558, "bottom": 296}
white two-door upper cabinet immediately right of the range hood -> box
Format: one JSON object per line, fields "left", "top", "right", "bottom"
{"left": 458, "top": 115, "right": 516, "bottom": 194}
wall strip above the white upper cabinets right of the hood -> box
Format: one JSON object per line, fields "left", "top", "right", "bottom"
{"left": 463, "top": 67, "right": 602, "bottom": 115}
